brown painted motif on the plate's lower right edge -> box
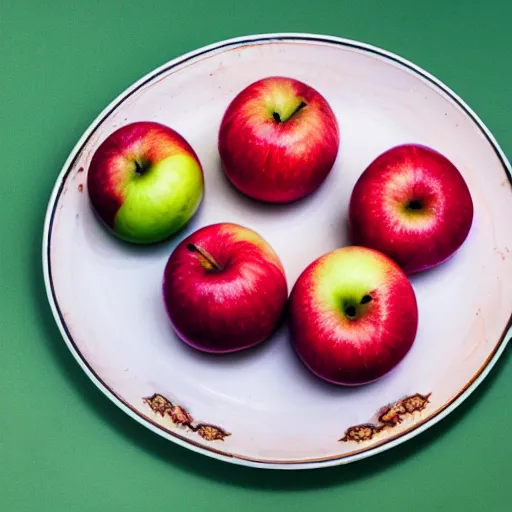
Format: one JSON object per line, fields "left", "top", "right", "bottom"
{"left": 339, "top": 393, "right": 431, "bottom": 443}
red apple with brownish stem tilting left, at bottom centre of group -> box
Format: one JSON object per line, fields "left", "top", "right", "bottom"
{"left": 163, "top": 223, "right": 288, "bottom": 353}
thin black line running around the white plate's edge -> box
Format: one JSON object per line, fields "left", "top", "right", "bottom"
{"left": 47, "top": 35, "right": 512, "bottom": 465}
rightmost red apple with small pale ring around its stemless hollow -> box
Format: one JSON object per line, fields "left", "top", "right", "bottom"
{"left": 349, "top": 144, "right": 473, "bottom": 274}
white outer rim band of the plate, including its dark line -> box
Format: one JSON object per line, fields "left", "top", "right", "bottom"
{"left": 42, "top": 32, "right": 512, "bottom": 470}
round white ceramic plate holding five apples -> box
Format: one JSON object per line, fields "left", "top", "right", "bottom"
{"left": 43, "top": 34, "right": 512, "bottom": 468}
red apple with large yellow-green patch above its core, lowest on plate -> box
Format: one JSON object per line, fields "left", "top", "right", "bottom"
{"left": 289, "top": 246, "right": 418, "bottom": 386}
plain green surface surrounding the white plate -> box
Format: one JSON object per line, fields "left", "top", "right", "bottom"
{"left": 0, "top": 0, "right": 512, "bottom": 512}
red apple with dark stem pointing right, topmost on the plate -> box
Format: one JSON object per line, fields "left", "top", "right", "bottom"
{"left": 218, "top": 77, "right": 339, "bottom": 203}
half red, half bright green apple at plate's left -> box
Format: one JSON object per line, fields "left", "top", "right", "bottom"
{"left": 87, "top": 121, "right": 204, "bottom": 244}
